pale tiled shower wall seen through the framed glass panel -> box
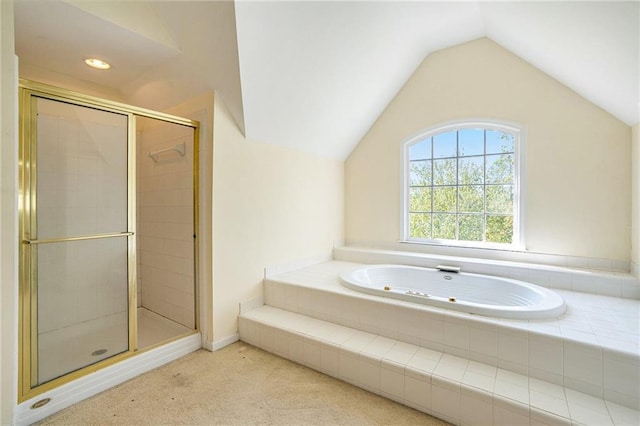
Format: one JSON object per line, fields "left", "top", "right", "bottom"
{"left": 37, "top": 100, "right": 127, "bottom": 333}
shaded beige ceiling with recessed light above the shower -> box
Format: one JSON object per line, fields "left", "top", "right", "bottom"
{"left": 15, "top": 0, "right": 244, "bottom": 129}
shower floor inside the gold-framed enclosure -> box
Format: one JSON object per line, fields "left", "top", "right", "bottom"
{"left": 34, "top": 307, "right": 192, "bottom": 383}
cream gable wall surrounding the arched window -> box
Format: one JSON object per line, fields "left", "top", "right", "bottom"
{"left": 345, "top": 38, "right": 631, "bottom": 264}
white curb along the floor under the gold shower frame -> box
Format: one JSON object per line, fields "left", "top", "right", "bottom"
{"left": 16, "top": 333, "right": 202, "bottom": 425}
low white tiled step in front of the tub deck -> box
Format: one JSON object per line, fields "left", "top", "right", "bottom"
{"left": 239, "top": 305, "right": 640, "bottom": 426}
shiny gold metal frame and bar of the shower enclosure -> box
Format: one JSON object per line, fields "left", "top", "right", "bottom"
{"left": 18, "top": 80, "right": 200, "bottom": 402}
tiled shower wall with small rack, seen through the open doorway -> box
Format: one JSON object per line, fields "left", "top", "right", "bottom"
{"left": 137, "top": 121, "right": 195, "bottom": 328}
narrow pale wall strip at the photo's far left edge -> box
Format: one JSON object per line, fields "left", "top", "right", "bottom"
{"left": 0, "top": 0, "right": 18, "bottom": 425}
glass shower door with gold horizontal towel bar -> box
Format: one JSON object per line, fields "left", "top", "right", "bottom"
{"left": 25, "top": 97, "right": 134, "bottom": 387}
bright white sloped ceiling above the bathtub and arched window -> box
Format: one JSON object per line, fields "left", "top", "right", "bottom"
{"left": 236, "top": 1, "right": 640, "bottom": 158}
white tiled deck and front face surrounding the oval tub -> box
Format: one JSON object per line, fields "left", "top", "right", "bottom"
{"left": 240, "top": 261, "right": 640, "bottom": 422}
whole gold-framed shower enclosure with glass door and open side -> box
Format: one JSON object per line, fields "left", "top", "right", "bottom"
{"left": 19, "top": 81, "right": 198, "bottom": 400}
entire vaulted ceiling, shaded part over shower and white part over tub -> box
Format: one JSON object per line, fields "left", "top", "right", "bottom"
{"left": 15, "top": 0, "right": 640, "bottom": 159}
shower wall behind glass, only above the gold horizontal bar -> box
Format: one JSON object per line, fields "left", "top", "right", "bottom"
{"left": 38, "top": 107, "right": 127, "bottom": 238}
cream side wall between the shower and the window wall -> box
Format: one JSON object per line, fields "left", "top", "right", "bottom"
{"left": 213, "top": 97, "right": 343, "bottom": 340}
